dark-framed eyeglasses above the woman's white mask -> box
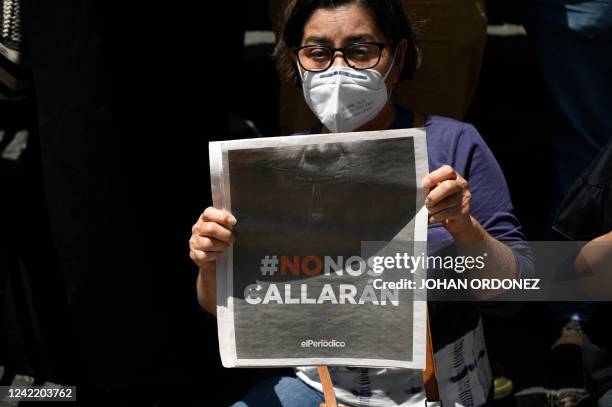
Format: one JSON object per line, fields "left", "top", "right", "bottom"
{"left": 297, "top": 42, "right": 386, "bottom": 72}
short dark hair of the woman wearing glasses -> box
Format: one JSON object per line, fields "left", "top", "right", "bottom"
{"left": 274, "top": 0, "right": 420, "bottom": 86}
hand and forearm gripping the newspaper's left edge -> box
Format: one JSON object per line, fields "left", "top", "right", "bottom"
{"left": 189, "top": 206, "right": 237, "bottom": 314}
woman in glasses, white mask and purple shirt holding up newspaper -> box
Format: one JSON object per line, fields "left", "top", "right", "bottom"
{"left": 189, "top": 0, "right": 531, "bottom": 407}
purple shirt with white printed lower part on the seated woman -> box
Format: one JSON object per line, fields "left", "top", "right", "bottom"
{"left": 297, "top": 107, "right": 533, "bottom": 406}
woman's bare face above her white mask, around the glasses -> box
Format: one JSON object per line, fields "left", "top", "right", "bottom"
{"left": 301, "top": 3, "right": 405, "bottom": 90}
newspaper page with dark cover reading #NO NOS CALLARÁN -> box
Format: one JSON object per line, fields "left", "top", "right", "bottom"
{"left": 209, "top": 129, "right": 428, "bottom": 369}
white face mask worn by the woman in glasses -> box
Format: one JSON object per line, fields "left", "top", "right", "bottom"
{"left": 298, "top": 50, "right": 395, "bottom": 133}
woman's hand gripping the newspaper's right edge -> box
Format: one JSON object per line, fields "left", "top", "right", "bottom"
{"left": 423, "top": 165, "right": 472, "bottom": 235}
